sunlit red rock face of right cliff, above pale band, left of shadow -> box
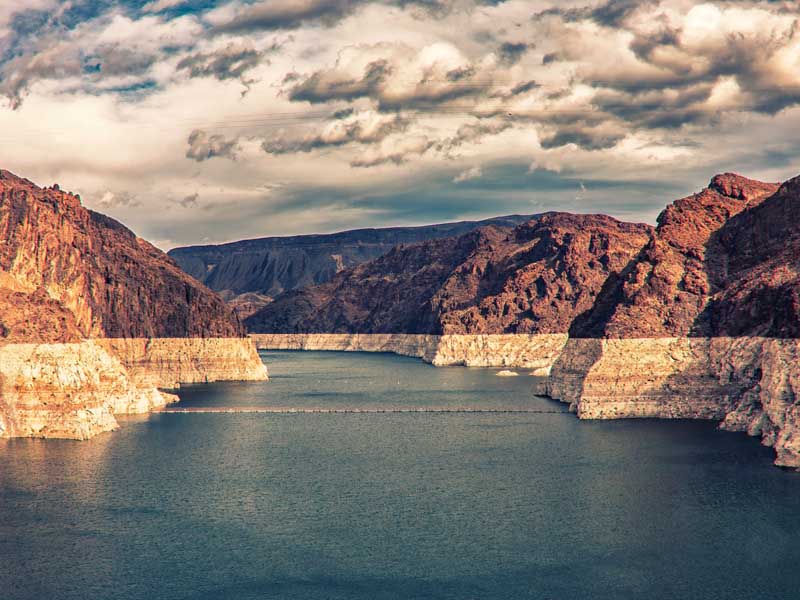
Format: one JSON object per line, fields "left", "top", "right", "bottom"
{"left": 570, "top": 173, "right": 778, "bottom": 338}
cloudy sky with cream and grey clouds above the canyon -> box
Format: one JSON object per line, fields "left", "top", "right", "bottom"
{"left": 0, "top": 0, "right": 800, "bottom": 249}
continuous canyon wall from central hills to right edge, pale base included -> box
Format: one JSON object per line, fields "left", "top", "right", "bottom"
{"left": 247, "top": 173, "right": 800, "bottom": 467}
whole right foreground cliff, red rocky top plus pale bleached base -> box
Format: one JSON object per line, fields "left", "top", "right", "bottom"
{"left": 547, "top": 174, "right": 800, "bottom": 467}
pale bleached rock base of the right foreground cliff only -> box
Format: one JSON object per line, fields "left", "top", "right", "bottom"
{"left": 545, "top": 337, "right": 800, "bottom": 467}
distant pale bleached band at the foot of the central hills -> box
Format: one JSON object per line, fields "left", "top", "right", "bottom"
{"left": 250, "top": 333, "right": 567, "bottom": 372}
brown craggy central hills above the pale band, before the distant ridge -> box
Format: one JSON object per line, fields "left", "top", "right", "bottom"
{"left": 246, "top": 213, "right": 651, "bottom": 334}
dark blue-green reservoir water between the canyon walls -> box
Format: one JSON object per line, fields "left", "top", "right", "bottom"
{"left": 0, "top": 352, "right": 800, "bottom": 600}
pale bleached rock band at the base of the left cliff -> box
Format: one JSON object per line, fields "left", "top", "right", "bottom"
{"left": 0, "top": 338, "right": 267, "bottom": 440}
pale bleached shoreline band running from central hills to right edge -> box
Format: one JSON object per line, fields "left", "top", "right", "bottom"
{"left": 250, "top": 334, "right": 800, "bottom": 468}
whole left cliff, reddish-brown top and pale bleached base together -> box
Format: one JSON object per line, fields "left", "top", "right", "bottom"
{"left": 0, "top": 171, "right": 266, "bottom": 439}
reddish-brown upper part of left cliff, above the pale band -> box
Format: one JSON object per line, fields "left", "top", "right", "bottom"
{"left": 0, "top": 171, "right": 242, "bottom": 342}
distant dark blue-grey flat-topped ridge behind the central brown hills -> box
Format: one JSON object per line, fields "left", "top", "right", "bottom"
{"left": 169, "top": 215, "right": 530, "bottom": 318}
